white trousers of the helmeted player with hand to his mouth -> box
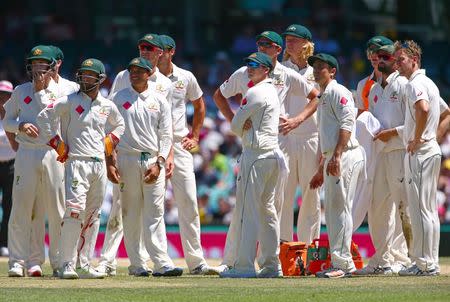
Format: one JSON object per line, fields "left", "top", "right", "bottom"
{"left": 8, "top": 144, "right": 64, "bottom": 268}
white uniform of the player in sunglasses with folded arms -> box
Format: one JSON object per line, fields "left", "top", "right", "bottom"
{"left": 227, "top": 79, "right": 284, "bottom": 272}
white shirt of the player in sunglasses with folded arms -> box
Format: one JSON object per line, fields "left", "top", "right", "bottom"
{"left": 231, "top": 79, "right": 280, "bottom": 151}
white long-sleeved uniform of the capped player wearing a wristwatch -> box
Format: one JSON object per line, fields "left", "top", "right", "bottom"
{"left": 113, "top": 88, "right": 174, "bottom": 270}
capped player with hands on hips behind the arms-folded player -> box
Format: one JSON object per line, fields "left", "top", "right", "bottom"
{"left": 213, "top": 31, "right": 319, "bottom": 270}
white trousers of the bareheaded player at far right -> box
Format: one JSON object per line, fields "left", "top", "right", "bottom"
{"left": 405, "top": 141, "right": 441, "bottom": 270}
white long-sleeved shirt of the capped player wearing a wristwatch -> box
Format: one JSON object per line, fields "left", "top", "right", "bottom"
{"left": 112, "top": 88, "right": 172, "bottom": 159}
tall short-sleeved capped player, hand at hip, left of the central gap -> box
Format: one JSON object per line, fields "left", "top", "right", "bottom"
{"left": 158, "top": 35, "right": 218, "bottom": 275}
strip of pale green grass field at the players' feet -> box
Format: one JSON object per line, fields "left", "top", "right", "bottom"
{"left": 0, "top": 258, "right": 450, "bottom": 302}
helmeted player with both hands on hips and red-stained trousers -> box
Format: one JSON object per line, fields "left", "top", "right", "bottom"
{"left": 38, "top": 59, "right": 125, "bottom": 279}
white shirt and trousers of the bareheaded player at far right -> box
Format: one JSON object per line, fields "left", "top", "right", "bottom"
{"left": 403, "top": 69, "right": 441, "bottom": 270}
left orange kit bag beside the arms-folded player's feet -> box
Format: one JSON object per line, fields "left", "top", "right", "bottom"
{"left": 279, "top": 242, "right": 307, "bottom": 276}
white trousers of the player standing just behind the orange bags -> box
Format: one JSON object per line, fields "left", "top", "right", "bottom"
{"left": 324, "top": 147, "right": 364, "bottom": 271}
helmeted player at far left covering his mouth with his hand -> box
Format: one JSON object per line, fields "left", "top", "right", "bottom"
{"left": 3, "top": 45, "right": 64, "bottom": 277}
